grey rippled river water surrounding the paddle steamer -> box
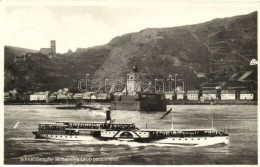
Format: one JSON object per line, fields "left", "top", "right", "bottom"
{"left": 4, "top": 105, "right": 257, "bottom": 165}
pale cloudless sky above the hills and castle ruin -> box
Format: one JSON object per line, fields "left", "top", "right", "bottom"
{"left": 4, "top": 1, "right": 259, "bottom": 53}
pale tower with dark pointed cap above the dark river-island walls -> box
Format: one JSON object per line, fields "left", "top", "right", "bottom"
{"left": 127, "top": 65, "right": 141, "bottom": 95}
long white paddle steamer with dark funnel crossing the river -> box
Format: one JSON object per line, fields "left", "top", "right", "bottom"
{"left": 33, "top": 110, "right": 229, "bottom": 145}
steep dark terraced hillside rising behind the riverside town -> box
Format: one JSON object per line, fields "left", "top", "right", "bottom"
{"left": 5, "top": 12, "right": 257, "bottom": 90}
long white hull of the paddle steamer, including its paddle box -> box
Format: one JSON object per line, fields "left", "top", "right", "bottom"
{"left": 33, "top": 131, "right": 229, "bottom": 146}
